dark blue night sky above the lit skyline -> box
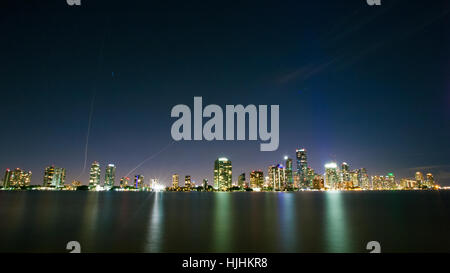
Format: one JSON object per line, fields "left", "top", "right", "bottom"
{"left": 0, "top": 0, "right": 450, "bottom": 185}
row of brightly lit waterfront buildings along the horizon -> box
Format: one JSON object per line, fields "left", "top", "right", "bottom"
{"left": 2, "top": 149, "right": 439, "bottom": 191}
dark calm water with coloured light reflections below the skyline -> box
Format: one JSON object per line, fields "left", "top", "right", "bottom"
{"left": 0, "top": 191, "right": 450, "bottom": 252}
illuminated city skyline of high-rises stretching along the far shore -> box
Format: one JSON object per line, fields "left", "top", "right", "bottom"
{"left": 2, "top": 148, "right": 445, "bottom": 191}
